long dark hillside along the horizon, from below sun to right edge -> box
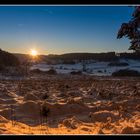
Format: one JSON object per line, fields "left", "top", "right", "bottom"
{"left": 14, "top": 52, "right": 140, "bottom": 62}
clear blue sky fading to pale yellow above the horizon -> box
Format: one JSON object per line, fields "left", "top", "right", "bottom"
{"left": 0, "top": 5, "right": 134, "bottom": 54}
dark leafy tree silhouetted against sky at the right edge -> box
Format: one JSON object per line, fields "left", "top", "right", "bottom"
{"left": 117, "top": 6, "right": 140, "bottom": 52}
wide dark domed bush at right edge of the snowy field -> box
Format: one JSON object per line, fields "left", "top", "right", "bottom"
{"left": 112, "top": 69, "right": 140, "bottom": 76}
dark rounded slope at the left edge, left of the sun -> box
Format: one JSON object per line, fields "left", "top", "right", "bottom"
{"left": 0, "top": 49, "right": 20, "bottom": 66}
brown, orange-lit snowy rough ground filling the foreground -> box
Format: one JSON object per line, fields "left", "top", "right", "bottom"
{"left": 0, "top": 75, "right": 140, "bottom": 135}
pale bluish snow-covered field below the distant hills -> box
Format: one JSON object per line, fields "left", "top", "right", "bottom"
{"left": 31, "top": 59, "right": 140, "bottom": 76}
